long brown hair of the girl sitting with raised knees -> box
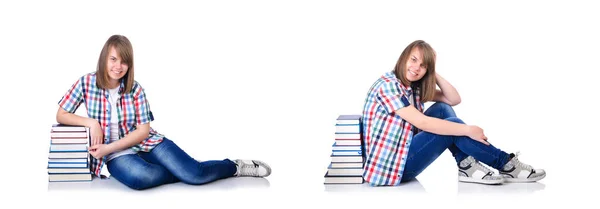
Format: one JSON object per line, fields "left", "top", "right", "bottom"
{"left": 394, "top": 40, "right": 436, "bottom": 102}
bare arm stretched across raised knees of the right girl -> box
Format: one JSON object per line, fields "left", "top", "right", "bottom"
{"left": 395, "top": 106, "right": 489, "bottom": 145}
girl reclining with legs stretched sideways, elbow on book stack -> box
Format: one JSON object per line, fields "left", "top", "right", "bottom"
{"left": 56, "top": 35, "right": 271, "bottom": 190}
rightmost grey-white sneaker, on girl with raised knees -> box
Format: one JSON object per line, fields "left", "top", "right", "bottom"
{"left": 499, "top": 152, "right": 546, "bottom": 183}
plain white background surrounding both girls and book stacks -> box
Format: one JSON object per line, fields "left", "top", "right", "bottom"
{"left": 0, "top": 0, "right": 600, "bottom": 208}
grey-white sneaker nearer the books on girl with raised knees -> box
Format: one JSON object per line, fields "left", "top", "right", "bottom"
{"left": 458, "top": 156, "right": 504, "bottom": 184}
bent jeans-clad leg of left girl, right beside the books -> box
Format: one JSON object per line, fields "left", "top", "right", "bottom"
{"left": 106, "top": 154, "right": 179, "bottom": 190}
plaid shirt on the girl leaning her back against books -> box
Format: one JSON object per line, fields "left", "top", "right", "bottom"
{"left": 362, "top": 72, "right": 424, "bottom": 186}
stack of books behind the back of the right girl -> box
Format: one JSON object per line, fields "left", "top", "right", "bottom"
{"left": 325, "top": 115, "right": 365, "bottom": 184}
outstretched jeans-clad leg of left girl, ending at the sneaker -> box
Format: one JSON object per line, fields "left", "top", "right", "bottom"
{"left": 140, "top": 138, "right": 237, "bottom": 185}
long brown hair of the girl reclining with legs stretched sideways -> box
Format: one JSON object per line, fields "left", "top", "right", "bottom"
{"left": 96, "top": 35, "right": 134, "bottom": 93}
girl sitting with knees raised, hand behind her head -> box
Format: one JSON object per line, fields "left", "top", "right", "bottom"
{"left": 363, "top": 40, "right": 546, "bottom": 186}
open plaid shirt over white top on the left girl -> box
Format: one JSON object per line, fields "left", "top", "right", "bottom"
{"left": 58, "top": 73, "right": 164, "bottom": 176}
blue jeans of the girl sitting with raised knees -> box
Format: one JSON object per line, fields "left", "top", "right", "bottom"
{"left": 401, "top": 102, "right": 510, "bottom": 182}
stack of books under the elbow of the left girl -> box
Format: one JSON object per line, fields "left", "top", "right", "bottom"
{"left": 48, "top": 124, "right": 92, "bottom": 182}
